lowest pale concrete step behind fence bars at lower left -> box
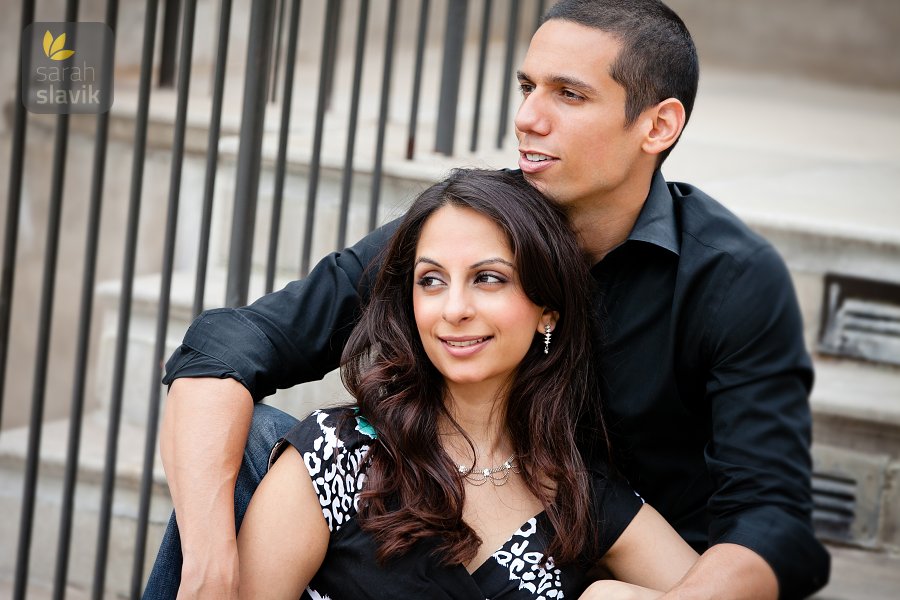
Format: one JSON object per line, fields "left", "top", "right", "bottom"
{"left": 0, "top": 413, "right": 172, "bottom": 597}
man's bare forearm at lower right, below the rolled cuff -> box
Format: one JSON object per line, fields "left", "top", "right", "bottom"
{"left": 662, "top": 544, "right": 778, "bottom": 600}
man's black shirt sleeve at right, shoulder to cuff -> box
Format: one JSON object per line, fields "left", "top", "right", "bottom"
{"left": 706, "top": 247, "right": 830, "bottom": 598}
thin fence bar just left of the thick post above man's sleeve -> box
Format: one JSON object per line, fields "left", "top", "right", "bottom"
{"left": 193, "top": 0, "right": 231, "bottom": 316}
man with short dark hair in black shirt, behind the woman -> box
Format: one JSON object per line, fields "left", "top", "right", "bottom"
{"left": 151, "top": 0, "right": 829, "bottom": 598}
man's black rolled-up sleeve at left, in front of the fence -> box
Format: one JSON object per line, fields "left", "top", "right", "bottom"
{"left": 162, "top": 221, "right": 397, "bottom": 401}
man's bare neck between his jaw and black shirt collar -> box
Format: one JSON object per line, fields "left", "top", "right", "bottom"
{"left": 569, "top": 172, "right": 652, "bottom": 264}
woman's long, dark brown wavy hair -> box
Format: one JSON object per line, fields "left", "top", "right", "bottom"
{"left": 342, "top": 170, "right": 608, "bottom": 564}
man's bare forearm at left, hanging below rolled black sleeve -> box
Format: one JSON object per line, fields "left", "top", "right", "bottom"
{"left": 159, "top": 378, "right": 253, "bottom": 599}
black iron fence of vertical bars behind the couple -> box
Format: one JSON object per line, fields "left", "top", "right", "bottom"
{"left": 0, "top": 0, "right": 544, "bottom": 599}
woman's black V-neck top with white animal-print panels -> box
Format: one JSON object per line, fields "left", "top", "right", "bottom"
{"left": 270, "top": 409, "right": 642, "bottom": 600}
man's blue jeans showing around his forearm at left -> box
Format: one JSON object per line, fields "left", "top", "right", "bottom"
{"left": 143, "top": 404, "right": 297, "bottom": 600}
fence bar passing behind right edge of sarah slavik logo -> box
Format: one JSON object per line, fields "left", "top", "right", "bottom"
{"left": 53, "top": 0, "right": 119, "bottom": 600}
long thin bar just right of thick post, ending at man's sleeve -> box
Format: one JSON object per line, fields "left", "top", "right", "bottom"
{"left": 266, "top": 0, "right": 300, "bottom": 294}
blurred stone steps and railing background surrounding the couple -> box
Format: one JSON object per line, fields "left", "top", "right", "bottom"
{"left": 0, "top": 0, "right": 900, "bottom": 598}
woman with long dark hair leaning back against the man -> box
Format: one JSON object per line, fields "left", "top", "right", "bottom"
{"left": 238, "top": 171, "right": 696, "bottom": 600}
